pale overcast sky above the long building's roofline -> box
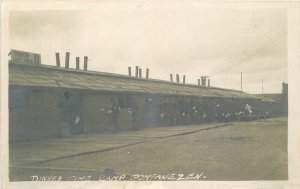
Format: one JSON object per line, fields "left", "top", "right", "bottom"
{"left": 9, "top": 5, "right": 287, "bottom": 93}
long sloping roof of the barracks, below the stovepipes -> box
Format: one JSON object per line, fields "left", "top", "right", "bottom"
{"left": 9, "top": 63, "right": 259, "bottom": 99}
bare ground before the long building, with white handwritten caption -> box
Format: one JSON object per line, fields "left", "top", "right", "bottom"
{"left": 10, "top": 117, "right": 288, "bottom": 181}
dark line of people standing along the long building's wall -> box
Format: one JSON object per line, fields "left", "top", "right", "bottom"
{"left": 111, "top": 96, "right": 262, "bottom": 131}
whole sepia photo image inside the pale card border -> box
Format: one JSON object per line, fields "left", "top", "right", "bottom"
{"left": 1, "top": 1, "right": 298, "bottom": 188}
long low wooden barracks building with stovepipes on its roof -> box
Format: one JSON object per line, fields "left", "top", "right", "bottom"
{"left": 9, "top": 50, "right": 279, "bottom": 141}
